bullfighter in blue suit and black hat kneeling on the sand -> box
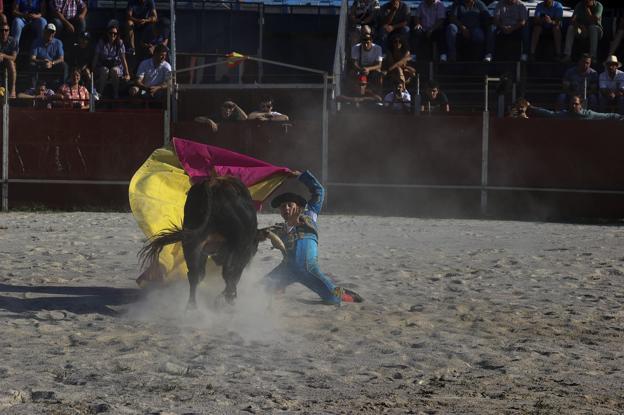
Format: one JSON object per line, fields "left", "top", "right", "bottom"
{"left": 265, "top": 170, "right": 363, "bottom": 304}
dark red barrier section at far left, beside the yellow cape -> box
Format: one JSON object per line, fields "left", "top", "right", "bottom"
{"left": 3, "top": 108, "right": 164, "bottom": 208}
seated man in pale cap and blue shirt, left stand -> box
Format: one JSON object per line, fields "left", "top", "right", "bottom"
{"left": 30, "top": 23, "right": 67, "bottom": 84}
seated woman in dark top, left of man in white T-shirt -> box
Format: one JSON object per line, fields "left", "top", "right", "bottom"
{"left": 91, "top": 23, "right": 130, "bottom": 99}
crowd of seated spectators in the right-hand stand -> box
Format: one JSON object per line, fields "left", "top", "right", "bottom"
{"left": 346, "top": 0, "right": 624, "bottom": 114}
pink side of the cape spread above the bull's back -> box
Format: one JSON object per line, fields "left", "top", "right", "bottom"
{"left": 173, "top": 137, "right": 290, "bottom": 187}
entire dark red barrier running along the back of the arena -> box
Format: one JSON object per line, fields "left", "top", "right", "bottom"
{"left": 2, "top": 109, "right": 624, "bottom": 218}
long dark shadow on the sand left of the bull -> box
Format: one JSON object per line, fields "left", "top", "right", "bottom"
{"left": 0, "top": 284, "right": 142, "bottom": 316}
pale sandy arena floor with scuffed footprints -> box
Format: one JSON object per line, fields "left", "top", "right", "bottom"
{"left": 0, "top": 212, "right": 624, "bottom": 415}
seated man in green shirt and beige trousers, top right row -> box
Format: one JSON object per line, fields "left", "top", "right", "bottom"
{"left": 563, "top": 0, "right": 602, "bottom": 62}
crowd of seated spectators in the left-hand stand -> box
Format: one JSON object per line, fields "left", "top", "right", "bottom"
{"left": 0, "top": 0, "right": 171, "bottom": 109}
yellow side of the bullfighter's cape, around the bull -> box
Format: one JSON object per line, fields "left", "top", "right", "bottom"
{"left": 128, "top": 147, "right": 286, "bottom": 287}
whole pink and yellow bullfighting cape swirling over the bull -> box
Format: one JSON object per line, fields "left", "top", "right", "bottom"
{"left": 128, "top": 138, "right": 290, "bottom": 287}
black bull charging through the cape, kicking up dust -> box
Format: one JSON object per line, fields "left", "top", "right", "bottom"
{"left": 139, "top": 176, "right": 272, "bottom": 308}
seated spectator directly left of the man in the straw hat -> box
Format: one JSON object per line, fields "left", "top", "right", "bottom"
{"left": 557, "top": 53, "right": 598, "bottom": 109}
